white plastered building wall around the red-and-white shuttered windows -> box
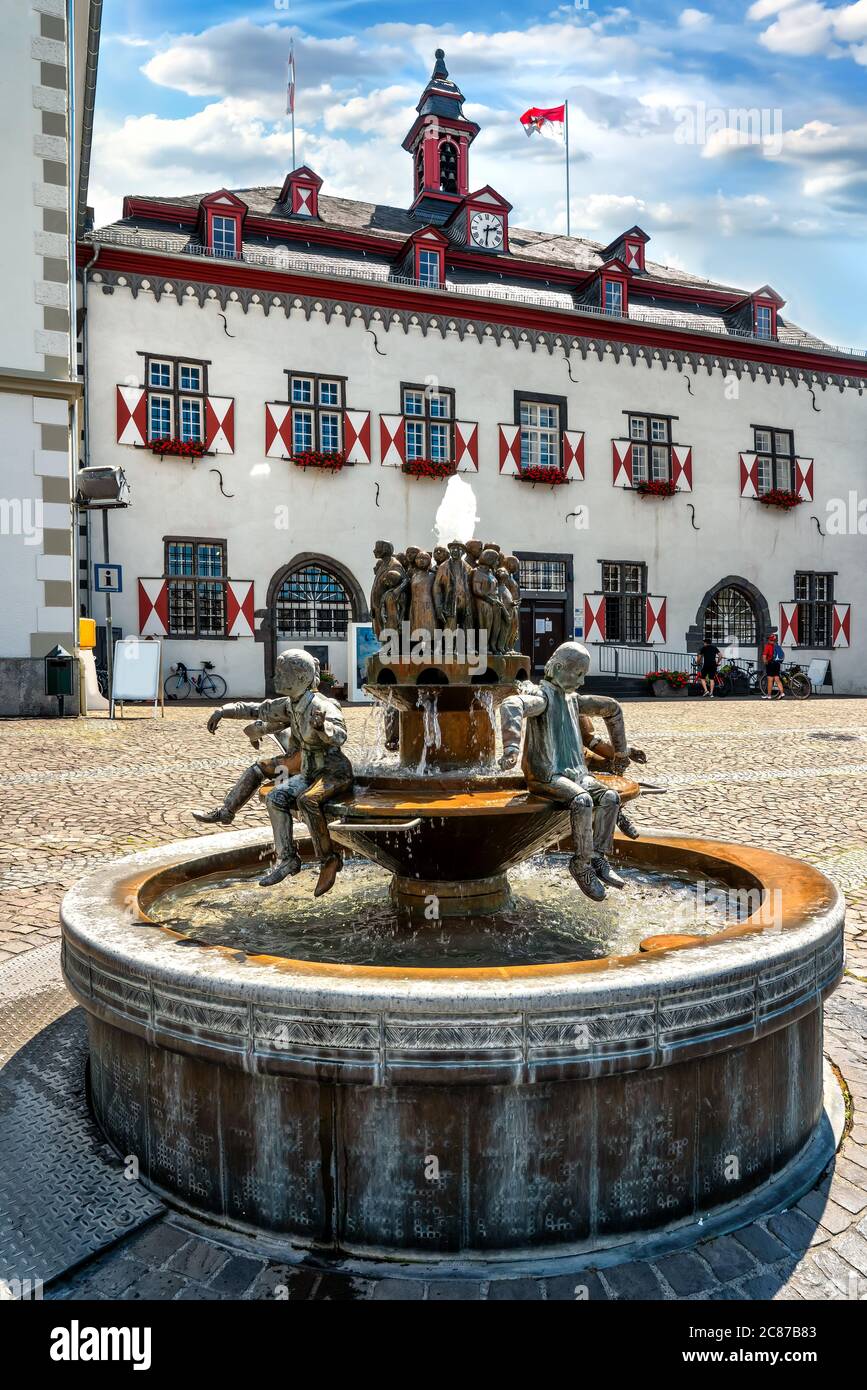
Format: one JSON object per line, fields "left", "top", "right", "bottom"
{"left": 83, "top": 279, "right": 867, "bottom": 695}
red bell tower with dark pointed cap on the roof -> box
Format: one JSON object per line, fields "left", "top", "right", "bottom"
{"left": 403, "top": 49, "right": 479, "bottom": 224}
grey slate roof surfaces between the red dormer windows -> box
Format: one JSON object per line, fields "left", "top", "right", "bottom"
{"left": 90, "top": 186, "right": 829, "bottom": 350}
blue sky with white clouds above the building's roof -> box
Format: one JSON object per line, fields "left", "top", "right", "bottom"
{"left": 90, "top": 0, "right": 867, "bottom": 348}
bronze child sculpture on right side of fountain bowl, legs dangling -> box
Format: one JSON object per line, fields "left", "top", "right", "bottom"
{"left": 500, "top": 642, "right": 628, "bottom": 902}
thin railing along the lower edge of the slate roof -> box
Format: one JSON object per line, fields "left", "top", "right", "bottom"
{"left": 88, "top": 227, "right": 867, "bottom": 359}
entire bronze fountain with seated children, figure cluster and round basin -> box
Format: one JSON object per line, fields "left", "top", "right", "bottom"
{"left": 63, "top": 541, "right": 843, "bottom": 1269}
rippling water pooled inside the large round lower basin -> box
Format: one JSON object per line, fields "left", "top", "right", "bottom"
{"left": 150, "top": 855, "right": 731, "bottom": 967}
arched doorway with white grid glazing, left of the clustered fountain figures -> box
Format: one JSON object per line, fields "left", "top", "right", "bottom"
{"left": 260, "top": 553, "right": 368, "bottom": 694}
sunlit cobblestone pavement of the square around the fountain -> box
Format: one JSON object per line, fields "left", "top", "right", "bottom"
{"left": 0, "top": 699, "right": 867, "bottom": 1301}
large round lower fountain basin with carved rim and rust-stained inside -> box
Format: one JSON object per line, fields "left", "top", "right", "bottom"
{"left": 61, "top": 830, "right": 843, "bottom": 1262}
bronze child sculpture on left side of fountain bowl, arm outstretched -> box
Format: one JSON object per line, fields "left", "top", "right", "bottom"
{"left": 193, "top": 651, "right": 353, "bottom": 898}
